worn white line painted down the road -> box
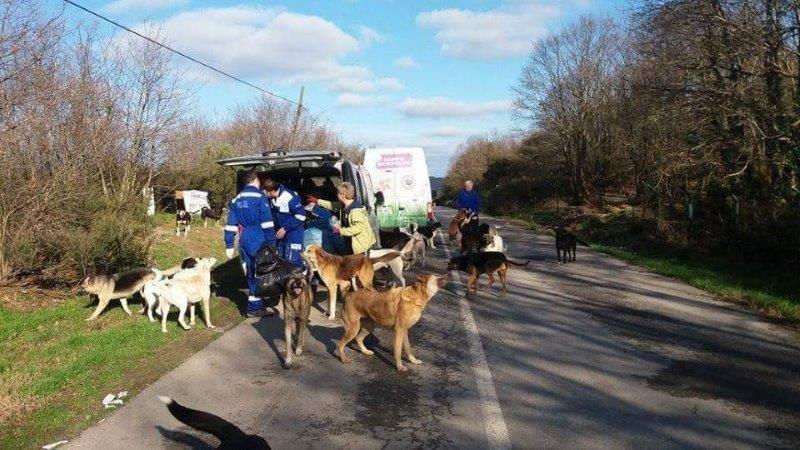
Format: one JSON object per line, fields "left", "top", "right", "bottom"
{"left": 440, "top": 232, "right": 511, "bottom": 449}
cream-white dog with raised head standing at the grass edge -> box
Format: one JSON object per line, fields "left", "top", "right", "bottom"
{"left": 155, "top": 258, "right": 217, "bottom": 333}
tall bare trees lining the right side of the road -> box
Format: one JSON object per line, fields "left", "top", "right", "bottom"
{"left": 449, "top": 0, "right": 800, "bottom": 261}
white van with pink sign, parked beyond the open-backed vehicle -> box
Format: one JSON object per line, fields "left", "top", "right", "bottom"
{"left": 364, "top": 147, "right": 433, "bottom": 228}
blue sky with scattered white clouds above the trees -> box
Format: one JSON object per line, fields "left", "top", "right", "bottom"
{"left": 62, "top": 0, "right": 627, "bottom": 176}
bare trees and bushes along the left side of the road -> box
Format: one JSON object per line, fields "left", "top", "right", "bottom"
{"left": 0, "top": 0, "right": 358, "bottom": 285}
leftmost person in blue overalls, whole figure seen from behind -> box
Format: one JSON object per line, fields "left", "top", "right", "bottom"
{"left": 225, "top": 170, "right": 275, "bottom": 317}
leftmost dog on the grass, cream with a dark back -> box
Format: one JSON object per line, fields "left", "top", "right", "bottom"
{"left": 81, "top": 267, "right": 157, "bottom": 320}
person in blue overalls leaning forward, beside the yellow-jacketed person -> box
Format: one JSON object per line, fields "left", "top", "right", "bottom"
{"left": 262, "top": 178, "right": 306, "bottom": 267}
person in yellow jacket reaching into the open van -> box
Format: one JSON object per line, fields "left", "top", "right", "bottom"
{"left": 306, "top": 182, "right": 376, "bottom": 255}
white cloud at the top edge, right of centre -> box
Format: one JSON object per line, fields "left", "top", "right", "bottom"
{"left": 417, "top": 0, "right": 564, "bottom": 59}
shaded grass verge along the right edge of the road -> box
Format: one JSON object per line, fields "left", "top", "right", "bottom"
{"left": 511, "top": 209, "right": 800, "bottom": 326}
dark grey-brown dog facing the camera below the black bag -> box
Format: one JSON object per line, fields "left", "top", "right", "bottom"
{"left": 283, "top": 268, "right": 314, "bottom": 369}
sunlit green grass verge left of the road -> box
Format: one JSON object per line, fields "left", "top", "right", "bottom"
{"left": 0, "top": 215, "right": 243, "bottom": 449}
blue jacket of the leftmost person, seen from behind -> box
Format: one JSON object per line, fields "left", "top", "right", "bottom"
{"left": 225, "top": 186, "right": 275, "bottom": 250}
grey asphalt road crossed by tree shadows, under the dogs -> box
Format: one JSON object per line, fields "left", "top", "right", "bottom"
{"left": 69, "top": 210, "right": 800, "bottom": 449}
